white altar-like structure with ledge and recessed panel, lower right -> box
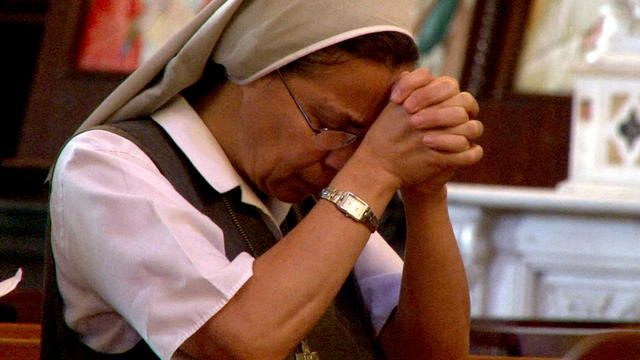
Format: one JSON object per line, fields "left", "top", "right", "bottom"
{"left": 449, "top": 184, "right": 640, "bottom": 321}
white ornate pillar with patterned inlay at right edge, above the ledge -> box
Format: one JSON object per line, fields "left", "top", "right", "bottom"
{"left": 560, "top": 0, "right": 640, "bottom": 200}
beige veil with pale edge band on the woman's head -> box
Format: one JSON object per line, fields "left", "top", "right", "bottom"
{"left": 78, "top": 0, "right": 417, "bottom": 131}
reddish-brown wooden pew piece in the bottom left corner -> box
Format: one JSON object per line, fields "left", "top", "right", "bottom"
{"left": 0, "top": 323, "right": 41, "bottom": 360}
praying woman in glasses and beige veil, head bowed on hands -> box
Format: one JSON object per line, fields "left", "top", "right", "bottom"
{"left": 43, "top": 0, "right": 482, "bottom": 359}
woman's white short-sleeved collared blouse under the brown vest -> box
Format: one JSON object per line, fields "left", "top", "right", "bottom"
{"left": 50, "top": 96, "right": 402, "bottom": 359}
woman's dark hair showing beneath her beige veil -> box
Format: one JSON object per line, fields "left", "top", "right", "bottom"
{"left": 182, "top": 31, "right": 418, "bottom": 103}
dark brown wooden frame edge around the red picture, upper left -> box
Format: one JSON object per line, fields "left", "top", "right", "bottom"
{"left": 15, "top": 0, "right": 123, "bottom": 168}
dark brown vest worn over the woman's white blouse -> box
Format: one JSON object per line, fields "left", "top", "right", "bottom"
{"left": 41, "top": 119, "right": 383, "bottom": 360}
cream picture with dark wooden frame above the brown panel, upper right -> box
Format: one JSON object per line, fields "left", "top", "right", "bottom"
{"left": 462, "top": 0, "right": 624, "bottom": 101}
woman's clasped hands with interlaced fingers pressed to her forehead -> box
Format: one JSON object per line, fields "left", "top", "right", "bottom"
{"left": 363, "top": 68, "right": 483, "bottom": 192}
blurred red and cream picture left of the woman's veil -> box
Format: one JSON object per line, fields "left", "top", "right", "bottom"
{"left": 76, "top": 0, "right": 210, "bottom": 74}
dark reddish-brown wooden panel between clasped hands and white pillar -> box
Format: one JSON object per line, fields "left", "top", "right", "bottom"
{"left": 455, "top": 98, "right": 571, "bottom": 187}
